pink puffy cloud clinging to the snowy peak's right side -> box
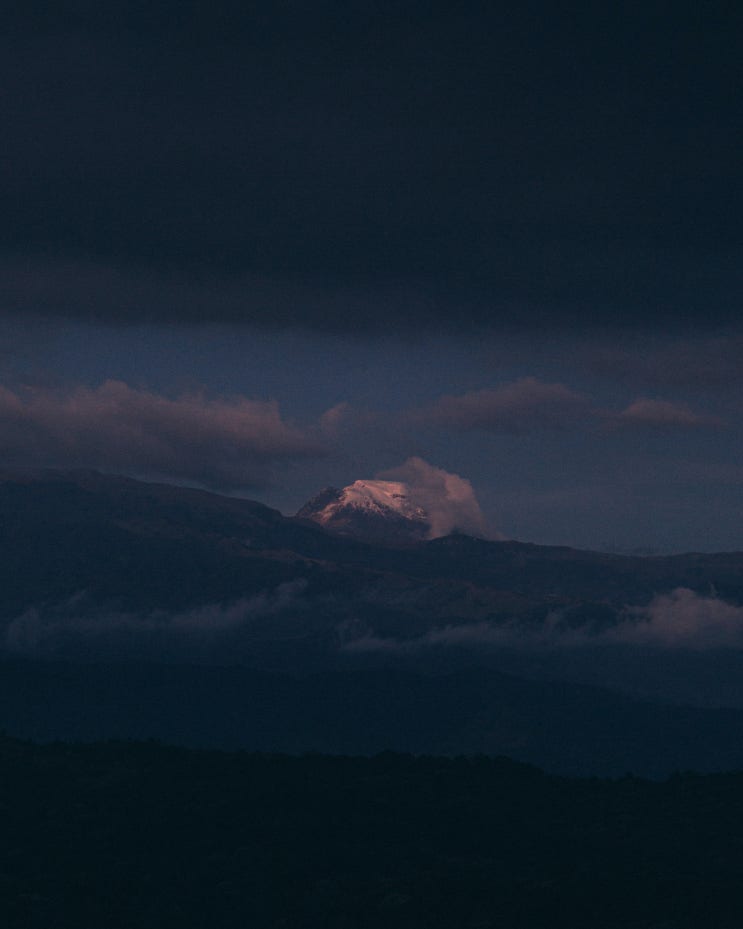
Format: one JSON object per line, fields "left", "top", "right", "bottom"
{"left": 376, "top": 457, "right": 492, "bottom": 539}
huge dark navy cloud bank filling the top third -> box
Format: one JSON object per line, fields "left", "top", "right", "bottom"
{"left": 0, "top": 2, "right": 743, "bottom": 331}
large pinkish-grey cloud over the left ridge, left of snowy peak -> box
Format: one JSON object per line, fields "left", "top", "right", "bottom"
{"left": 0, "top": 381, "right": 325, "bottom": 489}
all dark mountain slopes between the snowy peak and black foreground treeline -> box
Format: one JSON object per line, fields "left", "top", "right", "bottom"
{"left": 0, "top": 472, "right": 743, "bottom": 775}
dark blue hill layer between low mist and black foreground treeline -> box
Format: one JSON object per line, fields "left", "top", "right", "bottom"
{"left": 7, "top": 659, "right": 743, "bottom": 778}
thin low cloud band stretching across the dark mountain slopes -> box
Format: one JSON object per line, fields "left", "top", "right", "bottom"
{"left": 5, "top": 578, "right": 743, "bottom": 662}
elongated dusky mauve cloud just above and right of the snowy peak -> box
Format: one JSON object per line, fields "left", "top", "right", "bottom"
{"left": 418, "top": 377, "right": 593, "bottom": 435}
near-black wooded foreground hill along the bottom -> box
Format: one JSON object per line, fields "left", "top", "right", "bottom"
{"left": 0, "top": 738, "right": 743, "bottom": 929}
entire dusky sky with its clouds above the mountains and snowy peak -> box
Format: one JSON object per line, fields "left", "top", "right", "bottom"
{"left": 0, "top": 2, "right": 743, "bottom": 550}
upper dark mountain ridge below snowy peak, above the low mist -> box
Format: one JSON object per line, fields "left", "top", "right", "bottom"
{"left": 0, "top": 472, "right": 743, "bottom": 637}
